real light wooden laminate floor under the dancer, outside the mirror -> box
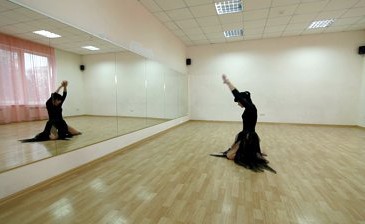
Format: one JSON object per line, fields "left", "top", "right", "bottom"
{"left": 0, "top": 121, "right": 365, "bottom": 224}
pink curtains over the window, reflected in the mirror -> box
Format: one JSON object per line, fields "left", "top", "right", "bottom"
{"left": 0, "top": 33, "right": 55, "bottom": 124}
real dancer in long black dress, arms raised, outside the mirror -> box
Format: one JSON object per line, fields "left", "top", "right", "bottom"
{"left": 211, "top": 75, "right": 268, "bottom": 169}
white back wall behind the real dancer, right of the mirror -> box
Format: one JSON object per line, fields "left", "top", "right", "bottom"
{"left": 188, "top": 31, "right": 365, "bottom": 125}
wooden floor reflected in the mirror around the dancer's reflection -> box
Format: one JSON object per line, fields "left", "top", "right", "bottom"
{"left": 0, "top": 116, "right": 167, "bottom": 172}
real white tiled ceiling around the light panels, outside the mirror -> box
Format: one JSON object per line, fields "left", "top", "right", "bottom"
{"left": 138, "top": 0, "right": 365, "bottom": 46}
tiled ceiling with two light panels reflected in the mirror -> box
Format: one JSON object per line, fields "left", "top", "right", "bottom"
{"left": 0, "top": 0, "right": 125, "bottom": 55}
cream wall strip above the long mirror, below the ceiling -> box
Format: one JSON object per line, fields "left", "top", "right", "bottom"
{"left": 12, "top": 0, "right": 186, "bottom": 73}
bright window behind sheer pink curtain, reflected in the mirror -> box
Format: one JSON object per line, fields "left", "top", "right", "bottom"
{"left": 0, "top": 39, "right": 55, "bottom": 105}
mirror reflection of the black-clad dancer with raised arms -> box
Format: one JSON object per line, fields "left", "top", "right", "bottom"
{"left": 28, "top": 81, "right": 81, "bottom": 141}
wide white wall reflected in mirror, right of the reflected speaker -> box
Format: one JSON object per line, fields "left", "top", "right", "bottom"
{"left": 82, "top": 52, "right": 187, "bottom": 119}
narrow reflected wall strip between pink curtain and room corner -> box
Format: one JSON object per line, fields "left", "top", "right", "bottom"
{"left": 55, "top": 49, "right": 85, "bottom": 116}
